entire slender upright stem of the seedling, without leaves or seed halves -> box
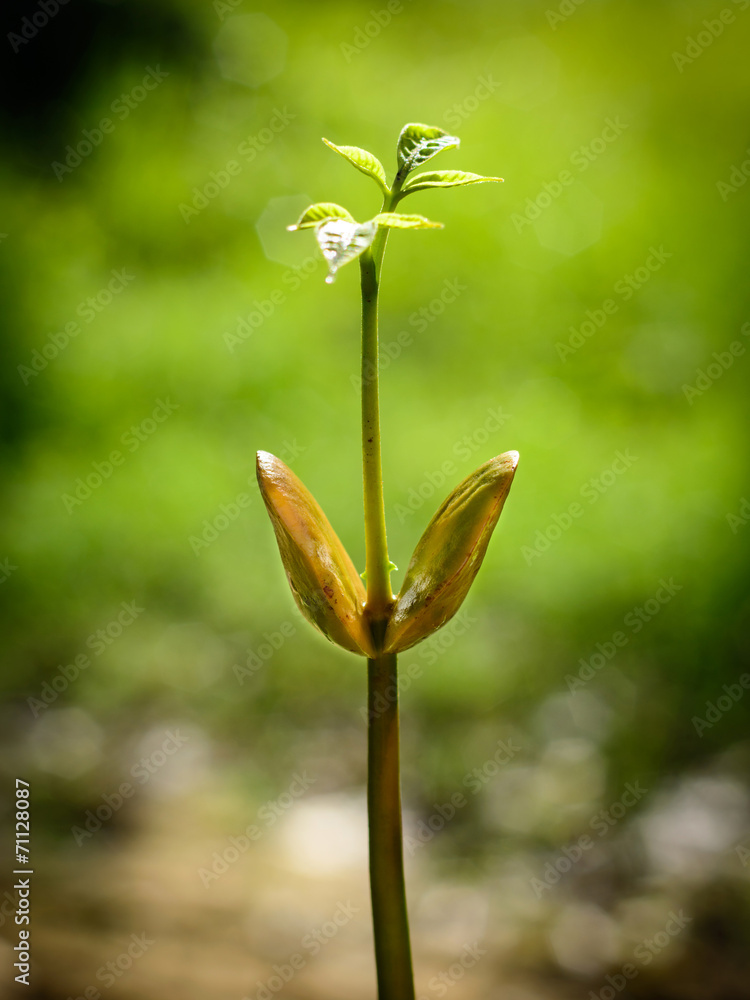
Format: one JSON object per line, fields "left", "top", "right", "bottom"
{"left": 360, "top": 184, "right": 414, "bottom": 1000}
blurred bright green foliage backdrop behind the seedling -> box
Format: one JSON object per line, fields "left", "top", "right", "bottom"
{"left": 0, "top": 0, "right": 750, "bottom": 988}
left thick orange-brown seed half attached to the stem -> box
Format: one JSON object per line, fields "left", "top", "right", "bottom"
{"left": 257, "top": 451, "right": 375, "bottom": 657}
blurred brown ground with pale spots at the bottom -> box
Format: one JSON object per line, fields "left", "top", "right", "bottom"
{"left": 3, "top": 756, "right": 748, "bottom": 1000}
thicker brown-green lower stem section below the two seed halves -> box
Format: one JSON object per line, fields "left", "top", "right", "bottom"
{"left": 367, "top": 653, "right": 414, "bottom": 1000}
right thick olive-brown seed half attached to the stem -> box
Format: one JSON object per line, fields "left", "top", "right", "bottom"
{"left": 385, "top": 451, "right": 518, "bottom": 653}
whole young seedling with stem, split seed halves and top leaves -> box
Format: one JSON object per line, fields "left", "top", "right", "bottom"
{"left": 257, "top": 123, "right": 518, "bottom": 1000}
